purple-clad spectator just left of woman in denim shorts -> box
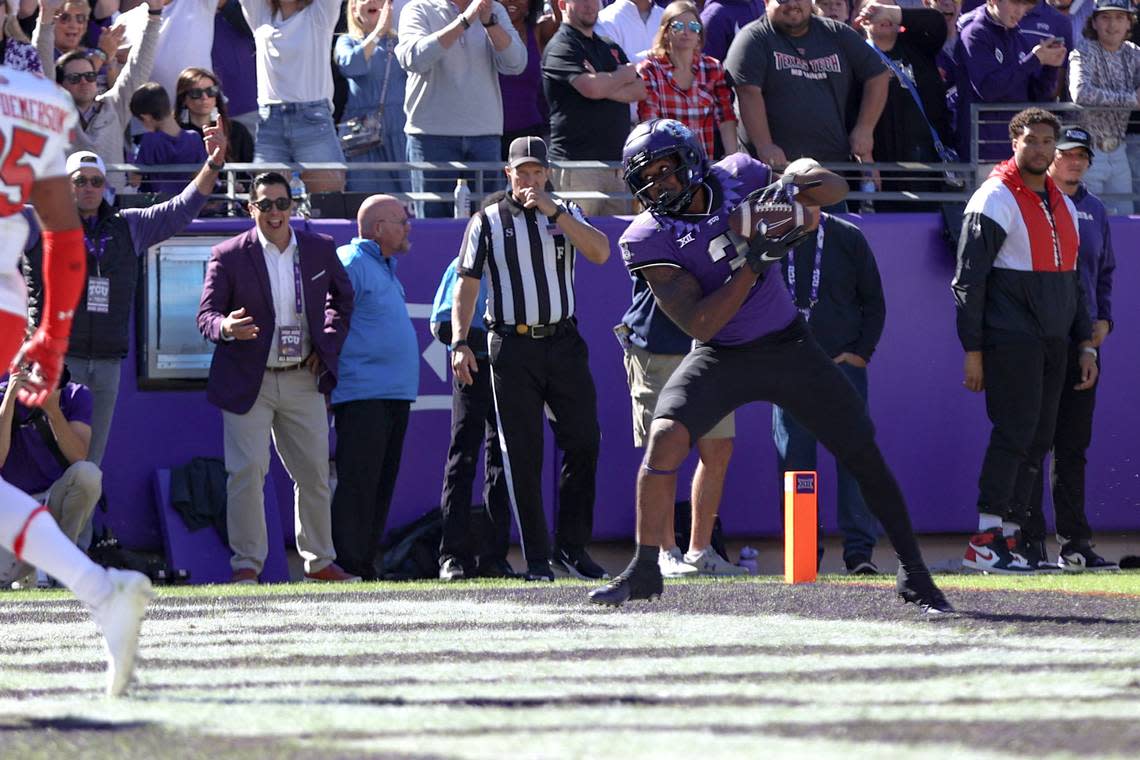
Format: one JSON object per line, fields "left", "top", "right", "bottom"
{"left": 210, "top": 0, "right": 258, "bottom": 139}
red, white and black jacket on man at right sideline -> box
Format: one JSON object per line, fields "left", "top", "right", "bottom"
{"left": 951, "top": 158, "right": 1092, "bottom": 351}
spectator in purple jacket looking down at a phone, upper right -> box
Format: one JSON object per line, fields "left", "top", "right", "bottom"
{"left": 954, "top": 0, "right": 1068, "bottom": 161}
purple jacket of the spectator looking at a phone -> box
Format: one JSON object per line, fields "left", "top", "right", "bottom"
{"left": 954, "top": 9, "right": 1060, "bottom": 161}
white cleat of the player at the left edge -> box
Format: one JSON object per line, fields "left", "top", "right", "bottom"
{"left": 91, "top": 567, "right": 154, "bottom": 696}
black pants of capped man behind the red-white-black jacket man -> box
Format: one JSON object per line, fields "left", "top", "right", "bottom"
{"left": 1025, "top": 343, "right": 1101, "bottom": 541}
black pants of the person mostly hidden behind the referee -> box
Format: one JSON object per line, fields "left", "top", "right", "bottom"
{"left": 439, "top": 358, "right": 511, "bottom": 570}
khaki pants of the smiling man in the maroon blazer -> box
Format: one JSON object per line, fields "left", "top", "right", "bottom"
{"left": 221, "top": 369, "right": 336, "bottom": 573}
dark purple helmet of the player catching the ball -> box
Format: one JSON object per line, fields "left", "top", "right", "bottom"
{"left": 621, "top": 119, "right": 708, "bottom": 214}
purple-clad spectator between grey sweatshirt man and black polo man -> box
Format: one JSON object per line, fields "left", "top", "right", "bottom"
{"left": 499, "top": 0, "right": 562, "bottom": 161}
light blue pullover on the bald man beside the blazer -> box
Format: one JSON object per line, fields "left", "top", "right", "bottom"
{"left": 332, "top": 237, "right": 420, "bottom": 403}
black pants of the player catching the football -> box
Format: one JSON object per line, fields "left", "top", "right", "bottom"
{"left": 653, "top": 317, "right": 925, "bottom": 570}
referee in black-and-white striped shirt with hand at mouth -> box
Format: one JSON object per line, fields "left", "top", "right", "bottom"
{"left": 451, "top": 137, "right": 610, "bottom": 581}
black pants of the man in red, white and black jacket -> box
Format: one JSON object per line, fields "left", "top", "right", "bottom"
{"left": 978, "top": 336, "right": 1068, "bottom": 525}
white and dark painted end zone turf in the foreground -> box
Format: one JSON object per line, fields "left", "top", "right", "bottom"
{"left": 0, "top": 573, "right": 1140, "bottom": 760}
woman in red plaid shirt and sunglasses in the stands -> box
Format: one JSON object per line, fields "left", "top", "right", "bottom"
{"left": 637, "top": 0, "right": 740, "bottom": 158}
